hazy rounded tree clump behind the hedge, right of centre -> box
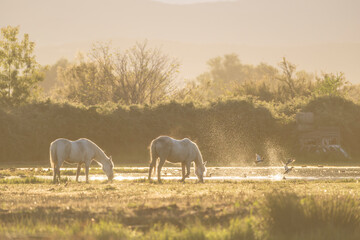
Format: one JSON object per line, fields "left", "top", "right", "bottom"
{"left": 182, "top": 54, "right": 278, "bottom": 100}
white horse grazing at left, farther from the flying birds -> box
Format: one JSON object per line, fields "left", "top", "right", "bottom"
{"left": 50, "top": 138, "right": 114, "bottom": 183}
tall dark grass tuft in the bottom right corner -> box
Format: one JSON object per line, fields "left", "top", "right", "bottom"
{"left": 263, "top": 192, "right": 360, "bottom": 239}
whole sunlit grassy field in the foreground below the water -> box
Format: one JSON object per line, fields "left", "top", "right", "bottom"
{"left": 0, "top": 177, "right": 360, "bottom": 239}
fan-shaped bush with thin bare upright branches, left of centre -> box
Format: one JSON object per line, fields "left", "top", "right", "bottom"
{"left": 114, "top": 42, "right": 180, "bottom": 104}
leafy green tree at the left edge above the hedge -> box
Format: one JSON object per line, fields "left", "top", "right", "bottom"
{"left": 0, "top": 26, "right": 44, "bottom": 104}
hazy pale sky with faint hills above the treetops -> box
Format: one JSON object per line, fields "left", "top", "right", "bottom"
{"left": 0, "top": 0, "right": 360, "bottom": 82}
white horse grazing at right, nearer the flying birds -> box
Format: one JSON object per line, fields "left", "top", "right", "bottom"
{"left": 149, "top": 136, "right": 206, "bottom": 182}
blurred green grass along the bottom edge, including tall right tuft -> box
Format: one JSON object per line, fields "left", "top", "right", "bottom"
{"left": 0, "top": 193, "right": 360, "bottom": 240}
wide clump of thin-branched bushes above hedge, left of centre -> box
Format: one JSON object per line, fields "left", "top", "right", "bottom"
{"left": 58, "top": 42, "right": 179, "bottom": 105}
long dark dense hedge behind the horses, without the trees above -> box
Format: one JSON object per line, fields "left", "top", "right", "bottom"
{"left": 0, "top": 97, "right": 360, "bottom": 165}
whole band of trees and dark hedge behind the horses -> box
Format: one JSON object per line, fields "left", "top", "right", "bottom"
{"left": 0, "top": 26, "right": 360, "bottom": 164}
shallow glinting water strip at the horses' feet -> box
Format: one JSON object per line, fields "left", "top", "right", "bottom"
{"left": 7, "top": 166, "right": 360, "bottom": 181}
